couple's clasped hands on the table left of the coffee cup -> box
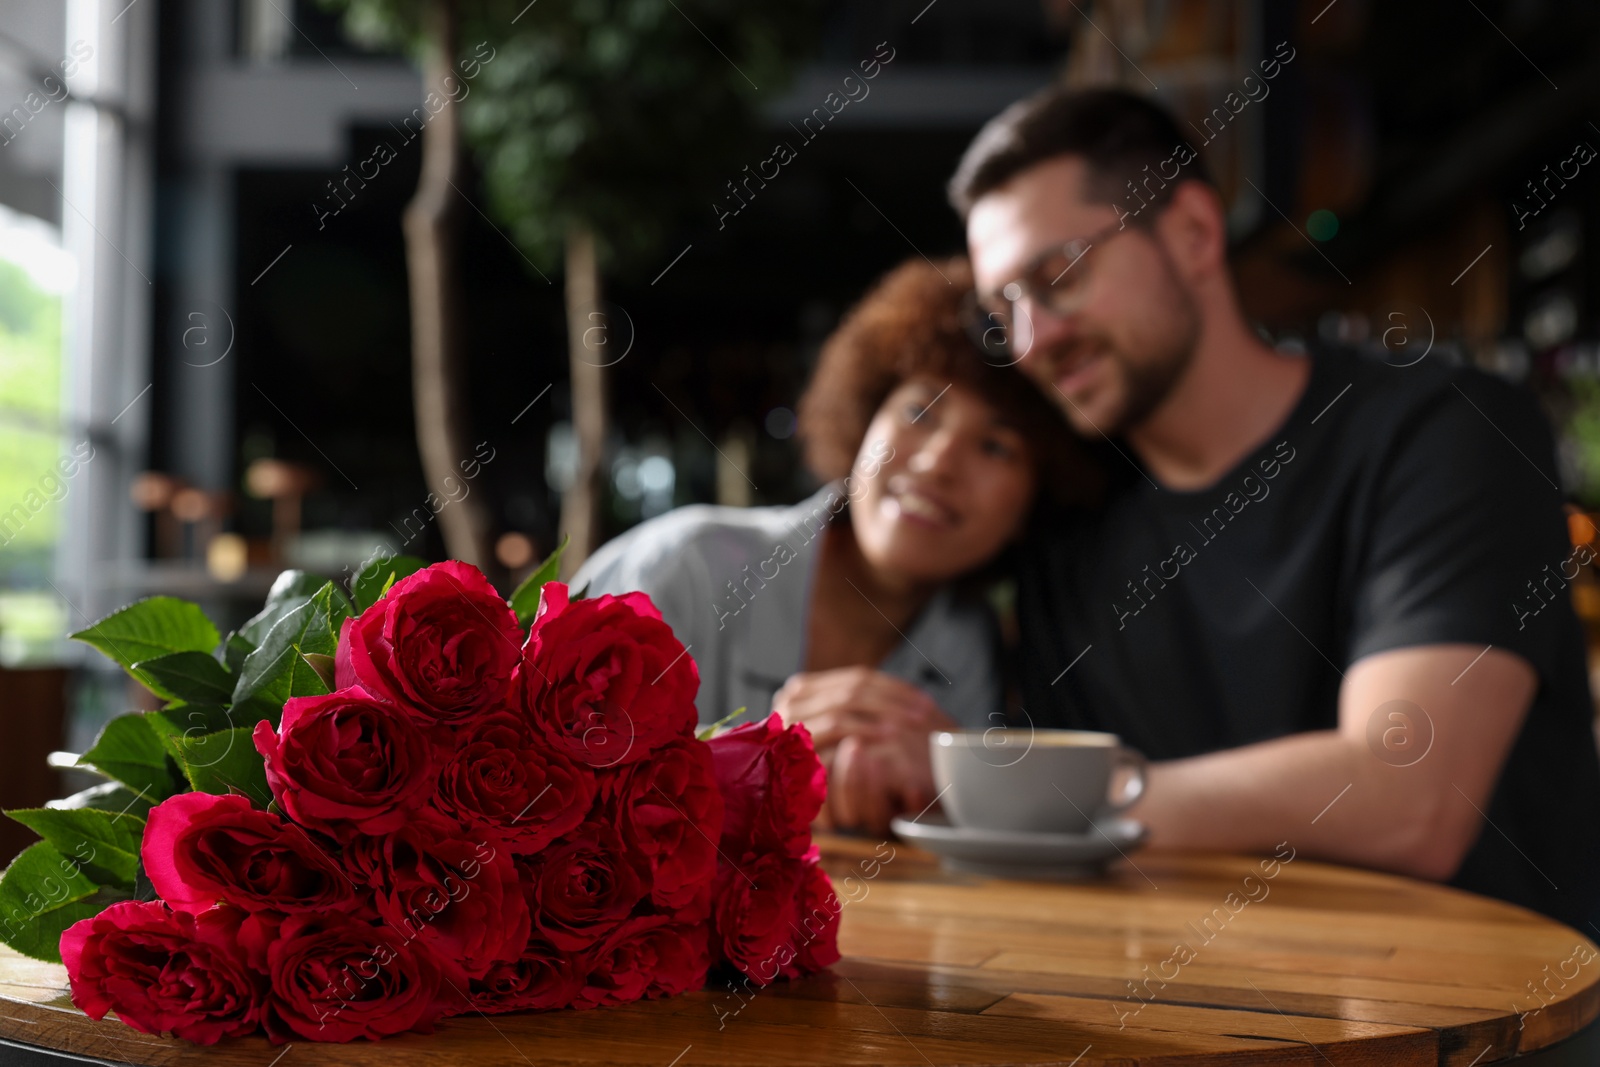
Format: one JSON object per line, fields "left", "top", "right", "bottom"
{"left": 773, "top": 667, "right": 957, "bottom": 833}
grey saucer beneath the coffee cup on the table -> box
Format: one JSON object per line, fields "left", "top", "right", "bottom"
{"left": 890, "top": 814, "right": 1147, "bottom": 880}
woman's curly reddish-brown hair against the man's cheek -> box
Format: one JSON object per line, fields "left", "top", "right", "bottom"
{"left": 798, "top": 256, "right": 1102, "bottom": 507}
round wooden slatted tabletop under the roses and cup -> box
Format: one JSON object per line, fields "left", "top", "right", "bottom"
{"left": 0, "top": 838, "right": 1600, "bottom": 1067}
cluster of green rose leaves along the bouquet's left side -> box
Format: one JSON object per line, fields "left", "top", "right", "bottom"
{"left": 0, "top": 571, "right": 340, "bottom": 963}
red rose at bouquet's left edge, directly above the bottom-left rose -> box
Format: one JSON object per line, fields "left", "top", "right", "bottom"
{"left": 141, "top": 793, "right": 355, "bottom": 913}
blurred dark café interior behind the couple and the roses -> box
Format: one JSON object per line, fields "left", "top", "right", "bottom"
{"left": 0, "top": 0, "right": 1600, "bottom": 854}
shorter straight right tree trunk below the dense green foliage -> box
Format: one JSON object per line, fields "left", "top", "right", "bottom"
{"left": 562, "top": 224, "right": 608, "bottom": 576}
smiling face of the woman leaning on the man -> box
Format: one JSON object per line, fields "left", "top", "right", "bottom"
{"left": 850, "top": 378, "right": 1034, "bottom": 584}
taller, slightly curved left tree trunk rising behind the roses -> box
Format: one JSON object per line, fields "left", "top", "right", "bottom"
{"left": 405, "top": 0, "right": 494, "bottom": 571}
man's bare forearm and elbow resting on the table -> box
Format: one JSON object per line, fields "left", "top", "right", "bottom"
{"left": 1130, "top": 645, "right": 1538, "bottom": 880}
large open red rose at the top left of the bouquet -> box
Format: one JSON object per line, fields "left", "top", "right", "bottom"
{"left": 334, "top": 560, "right": 522, "bottom": 726}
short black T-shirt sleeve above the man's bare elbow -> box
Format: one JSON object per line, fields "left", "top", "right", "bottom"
{"left": 1349, "top": 367, "right": 1571, "bottom": 677}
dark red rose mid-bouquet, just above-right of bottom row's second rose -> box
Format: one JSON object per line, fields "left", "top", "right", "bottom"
{"left": 346, "top": 816, "right": 530, "bottom": 985}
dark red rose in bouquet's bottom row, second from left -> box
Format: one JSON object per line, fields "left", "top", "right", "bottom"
{"left": 264, "top": 915, "right": 442, "bottom": 1041}
